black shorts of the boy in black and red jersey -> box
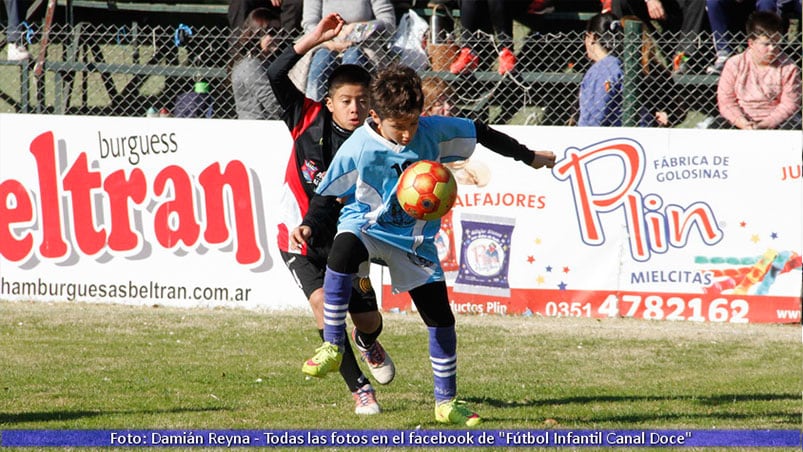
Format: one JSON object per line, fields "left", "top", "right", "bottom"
{"left": 281, "top": 250, "right": 378, "bottom": 314}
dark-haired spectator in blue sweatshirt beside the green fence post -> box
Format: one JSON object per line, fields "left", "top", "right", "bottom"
{"left": 577, "top": 13, "right": 623, "bottom": 126}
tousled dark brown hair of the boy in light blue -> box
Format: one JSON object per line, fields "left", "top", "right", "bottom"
{"left": 370, "top": 66, "right": 424, "bottom": 118}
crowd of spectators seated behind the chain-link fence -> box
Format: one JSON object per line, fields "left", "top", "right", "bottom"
{"left": 4, "top": 0, "right": 801, "bottom": 129}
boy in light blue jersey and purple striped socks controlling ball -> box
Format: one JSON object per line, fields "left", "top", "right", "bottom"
{"left": 292, "top": 66, "right": 555, "bottom": 426}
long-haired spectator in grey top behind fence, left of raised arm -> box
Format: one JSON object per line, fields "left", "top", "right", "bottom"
{"left": 231, "top": 8, "right": 281, "bottom": 119}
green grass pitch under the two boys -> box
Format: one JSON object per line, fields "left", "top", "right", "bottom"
{"left": 0, "top": 302, "right": 803, "bottom": 450}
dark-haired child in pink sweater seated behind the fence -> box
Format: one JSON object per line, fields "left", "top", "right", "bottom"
{"left": 711, "top": 11, "right": 801, "bottom": 130}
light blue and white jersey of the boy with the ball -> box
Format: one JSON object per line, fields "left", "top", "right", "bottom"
{"left": 317, "top": 116, "right": 477, "bottom": 264}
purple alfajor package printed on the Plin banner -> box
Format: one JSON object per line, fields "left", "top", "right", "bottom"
{"left": 454, "top": 213, "right": 516, "bottom": 297}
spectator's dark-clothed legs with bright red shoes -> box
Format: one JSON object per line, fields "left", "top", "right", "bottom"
{"left": 449, "top": 0, "right": 530, "bottom": 75}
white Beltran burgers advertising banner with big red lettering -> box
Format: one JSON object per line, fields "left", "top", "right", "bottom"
{"left": 0, "top": 115, "right": 307, "bottom": 308}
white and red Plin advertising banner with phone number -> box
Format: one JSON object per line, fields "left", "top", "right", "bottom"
{"left": 383, "top": 127, "right": 803, "bottom": 323}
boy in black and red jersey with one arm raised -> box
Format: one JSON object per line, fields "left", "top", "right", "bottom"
{"left": 268, "top": 14, "right": 395, "bottom": 414}
